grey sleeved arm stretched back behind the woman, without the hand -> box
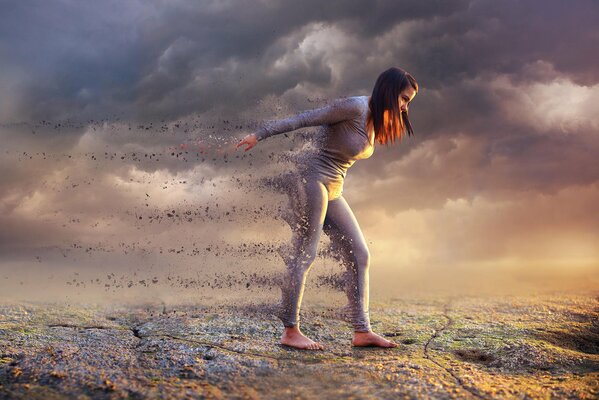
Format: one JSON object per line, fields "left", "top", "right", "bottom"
{"left": 256, "top": 98, "right": 362, "bottom": 141}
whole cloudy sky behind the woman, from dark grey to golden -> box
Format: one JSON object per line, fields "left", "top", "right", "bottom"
{"left": 0, "top": 0, "right": 599, "bottom": 296}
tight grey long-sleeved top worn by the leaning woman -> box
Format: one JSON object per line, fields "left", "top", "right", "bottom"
{"left": 256, "top": 96, "right": 374, "bottom": 200}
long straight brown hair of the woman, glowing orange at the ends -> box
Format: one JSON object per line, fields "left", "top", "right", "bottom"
{"left": 366, "top": 67, "right": 418, "bottom": 144}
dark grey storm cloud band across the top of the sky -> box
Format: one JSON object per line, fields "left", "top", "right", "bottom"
{"left": 0, "top": 1, "right": 598, "bottom": 120}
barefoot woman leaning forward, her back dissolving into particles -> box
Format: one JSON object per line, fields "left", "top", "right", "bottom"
{"left": 237, "top": 67, "right": 418, "bottom": 350}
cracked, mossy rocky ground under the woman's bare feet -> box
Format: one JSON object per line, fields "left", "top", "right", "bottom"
{"left": 0, "top": 293, "right": 599, "bottom": 399}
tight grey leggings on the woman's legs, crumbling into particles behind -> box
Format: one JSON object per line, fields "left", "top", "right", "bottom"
{"left": 279, "top": 178, "right": 371, "bottom": 332}
